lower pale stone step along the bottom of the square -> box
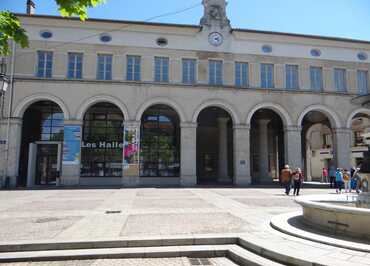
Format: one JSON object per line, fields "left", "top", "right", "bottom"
{"left": 0, "top": 245, "right": 282, "bottom": 266}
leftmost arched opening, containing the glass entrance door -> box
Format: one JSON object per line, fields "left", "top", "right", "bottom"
{"left": 18, "top": 101, "right": 64, "bottom": 186}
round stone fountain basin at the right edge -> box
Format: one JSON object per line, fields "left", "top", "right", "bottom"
{"left": 296, "top": 195, "right": 370, "bottom": 241}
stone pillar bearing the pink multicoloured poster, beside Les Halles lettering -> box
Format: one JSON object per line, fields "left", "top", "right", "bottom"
{"left": 122, "top": 121, "right": 141, "bottom": 187}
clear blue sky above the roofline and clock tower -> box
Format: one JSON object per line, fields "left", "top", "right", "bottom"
{"left": 0, "top": 0, "right": 370, "bottom": 41}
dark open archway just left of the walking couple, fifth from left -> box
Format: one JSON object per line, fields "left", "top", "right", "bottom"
{"left": 250, "top": 108, "right": 285, "bottom": 184}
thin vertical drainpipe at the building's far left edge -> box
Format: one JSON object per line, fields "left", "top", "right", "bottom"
{"left": 4, "top": 41, "right": 15, "bottom": 187}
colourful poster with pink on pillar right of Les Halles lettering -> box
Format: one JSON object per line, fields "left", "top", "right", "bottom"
{"left": 123, "top": 127, "right": 139, "bottom": 176}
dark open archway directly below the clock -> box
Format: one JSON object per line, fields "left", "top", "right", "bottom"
{"left": 196, "top": 107, "right": 234, "bottom": 184}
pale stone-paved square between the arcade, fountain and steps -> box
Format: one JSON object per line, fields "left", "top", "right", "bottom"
{"left": 0, "top": 188, "right": 370, "bottom": 265}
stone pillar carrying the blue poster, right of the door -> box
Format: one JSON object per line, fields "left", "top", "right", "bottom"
{"left": 60, "top": 120, "right": 83, "bottom": 186}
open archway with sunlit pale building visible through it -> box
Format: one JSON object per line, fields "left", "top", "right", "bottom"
{"left": 301, "top": 110, "right": 336, "bottom": 181}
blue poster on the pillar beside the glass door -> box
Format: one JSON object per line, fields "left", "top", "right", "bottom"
{"left": 63, "top": 125, "right": 81, "bottom": 165}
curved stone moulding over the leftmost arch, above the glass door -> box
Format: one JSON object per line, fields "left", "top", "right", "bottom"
{"left": 14, "top": 93, "right": 70, "bottom": 120}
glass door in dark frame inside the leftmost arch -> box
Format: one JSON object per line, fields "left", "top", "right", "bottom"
{"left": 36, "top": 144, "right": 59, "bottom": 185}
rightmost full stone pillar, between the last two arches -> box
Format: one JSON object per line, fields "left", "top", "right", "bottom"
{"left": 333, "top": 128, "right": 351, "bottom": 169}
